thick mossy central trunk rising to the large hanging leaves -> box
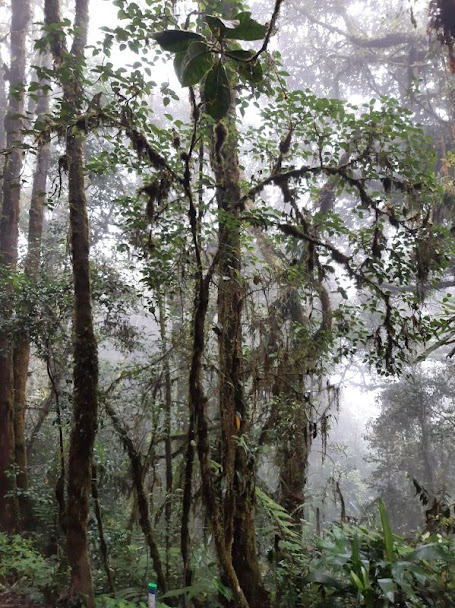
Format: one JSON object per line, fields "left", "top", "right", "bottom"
{"left": 211, "top": 92, "right": 269, "bottom": 608}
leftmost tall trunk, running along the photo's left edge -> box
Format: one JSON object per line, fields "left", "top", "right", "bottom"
{"left": 0, "top": 0, "right": 31, "bottom": 530}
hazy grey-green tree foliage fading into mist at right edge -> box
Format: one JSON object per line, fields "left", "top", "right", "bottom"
{"left": 366, "top": 363, "right": 455, "bottom": 534}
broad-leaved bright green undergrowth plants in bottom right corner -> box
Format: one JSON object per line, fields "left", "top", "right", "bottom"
{"left": 302, "top": 503, "right": 455, "bottom": 608}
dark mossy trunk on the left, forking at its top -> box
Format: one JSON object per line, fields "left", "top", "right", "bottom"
{"left": 45, "top": 0, "right": 98, "bottom": 608}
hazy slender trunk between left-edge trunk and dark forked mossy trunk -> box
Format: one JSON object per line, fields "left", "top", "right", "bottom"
{"left": 13, "top": 60, "right": 50, "bottom": 521}
